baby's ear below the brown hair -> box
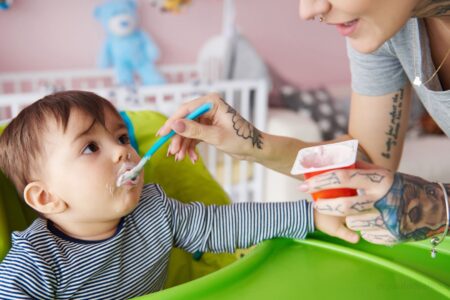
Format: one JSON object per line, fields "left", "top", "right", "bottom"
{"left": 23, "top": 181, "right": 67, "bottom": 215}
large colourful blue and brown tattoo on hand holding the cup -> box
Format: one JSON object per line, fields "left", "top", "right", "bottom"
{"left": 374, "top": 173, "right": 447, "bottom": 241}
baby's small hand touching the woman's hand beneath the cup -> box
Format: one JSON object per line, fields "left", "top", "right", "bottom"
{"left": 314, "top": 210, "right": 359, "bottom": 244}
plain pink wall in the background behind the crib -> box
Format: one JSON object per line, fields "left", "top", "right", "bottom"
{"left": 0, "top": 0, "right": 350, "bottom": 87}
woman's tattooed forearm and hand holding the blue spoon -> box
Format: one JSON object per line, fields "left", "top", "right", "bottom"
{"left": 159, "top": 94, "right": 369, "bottom": 176}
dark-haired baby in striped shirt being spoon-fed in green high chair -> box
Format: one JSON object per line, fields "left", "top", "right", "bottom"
{"left": 0, "top": 91, "right": 352, "bottom": 299}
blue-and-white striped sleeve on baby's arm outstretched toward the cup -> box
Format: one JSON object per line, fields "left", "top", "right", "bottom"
{"left": 160, "top": 189, "right": 314, "bottom": 252}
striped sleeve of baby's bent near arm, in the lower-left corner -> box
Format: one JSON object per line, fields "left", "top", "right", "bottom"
{"left": 0, "top": 242, "right": 56, "bottom": 299}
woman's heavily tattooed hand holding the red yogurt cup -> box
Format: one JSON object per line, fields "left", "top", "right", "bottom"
{"left": 300, "top": 162, "right": 449, "bottom": 245}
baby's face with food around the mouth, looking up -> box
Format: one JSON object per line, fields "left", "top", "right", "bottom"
{"left": 42, "top": 109, "right": 143, "bottom": 224}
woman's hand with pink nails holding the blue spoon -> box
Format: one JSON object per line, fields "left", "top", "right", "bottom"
{"left": 158, "top": 94, "right": 263, "bottom": 162}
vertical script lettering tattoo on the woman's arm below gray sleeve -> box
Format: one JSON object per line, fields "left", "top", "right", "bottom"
{"left": 381, "top": 89, "right": 404, "bottom": 159}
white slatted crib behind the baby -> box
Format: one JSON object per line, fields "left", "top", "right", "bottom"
{"left": 0, "top": 65, "right": 268, "bottom": 202}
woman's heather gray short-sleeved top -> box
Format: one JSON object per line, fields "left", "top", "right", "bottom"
{"left": 347, "top": 18, "right": 450, "bottom": 137}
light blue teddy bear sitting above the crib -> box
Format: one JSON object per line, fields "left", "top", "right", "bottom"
{"left": 94, "top": 0, "right": 165, "bottom": 85}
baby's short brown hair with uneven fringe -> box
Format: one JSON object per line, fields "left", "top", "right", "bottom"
{"left": 0, "top": 91, "right": 120, "bottom": 194}
